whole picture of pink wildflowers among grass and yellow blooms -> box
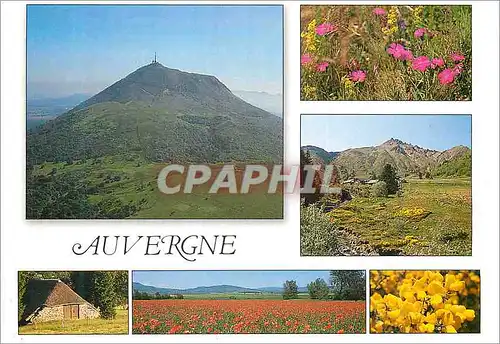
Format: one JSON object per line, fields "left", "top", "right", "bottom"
{"left": 301, "top": 5, "right": 472, "bottom": 101}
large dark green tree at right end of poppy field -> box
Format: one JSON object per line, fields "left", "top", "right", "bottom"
{"left": 330, "top": 270, "right": 366, "bottom": 300}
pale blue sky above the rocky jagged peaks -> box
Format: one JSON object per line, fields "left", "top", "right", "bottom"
{"left": 300, "top": 115, "right": 472, "bottom": 151}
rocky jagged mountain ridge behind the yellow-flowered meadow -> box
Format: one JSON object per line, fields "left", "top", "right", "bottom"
{"left": 302, "top": 138, "right": 471, "bottom": 178}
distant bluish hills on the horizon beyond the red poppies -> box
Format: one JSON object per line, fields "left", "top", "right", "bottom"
{"left": 132, "top": 282, "right": 307, "bottom": 295}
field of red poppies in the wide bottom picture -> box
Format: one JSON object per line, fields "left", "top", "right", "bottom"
{"left": 132, "top": 300, "right": 366, "bottom": 334}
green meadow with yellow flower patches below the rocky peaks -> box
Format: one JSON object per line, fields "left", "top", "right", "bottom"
{"left": 329, "top": 178, "right": 472, "bottom": 255}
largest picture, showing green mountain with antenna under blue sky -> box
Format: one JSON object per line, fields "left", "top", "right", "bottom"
{"left": 26, "top": 5, "right": 283, "bottom": 219}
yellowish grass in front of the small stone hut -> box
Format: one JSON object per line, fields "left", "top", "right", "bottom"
{"left": 19, "top": 309, "right": 128, "bottom": 334}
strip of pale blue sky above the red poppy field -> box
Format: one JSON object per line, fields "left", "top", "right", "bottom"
{"left": 132, "top": 270, "right": 330, "bottom": 289}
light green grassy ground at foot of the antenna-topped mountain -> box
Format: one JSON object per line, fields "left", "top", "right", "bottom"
{"left": 29, "top": 154, "right": 283, "bottom": 219}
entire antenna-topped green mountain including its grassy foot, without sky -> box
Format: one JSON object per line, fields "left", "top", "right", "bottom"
{"left": 26, "top": 63, "right": 283, "bottom": 219}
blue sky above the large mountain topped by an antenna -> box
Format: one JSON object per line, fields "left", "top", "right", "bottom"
{"left": 27, "top": 5, "right": 283, "bottom": 97}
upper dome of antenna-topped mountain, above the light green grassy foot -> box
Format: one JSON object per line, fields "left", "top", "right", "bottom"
{"left": 27, "top": 62, "right": 283, "bottom": 165}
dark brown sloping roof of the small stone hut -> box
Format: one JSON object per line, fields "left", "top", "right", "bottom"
{"left": 23, "top": 279, "right": 92, "bottom": 318}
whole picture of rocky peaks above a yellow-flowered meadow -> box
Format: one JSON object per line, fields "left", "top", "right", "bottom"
{"left": 300, "top": 115, "right": 472, "bottom": 256}
